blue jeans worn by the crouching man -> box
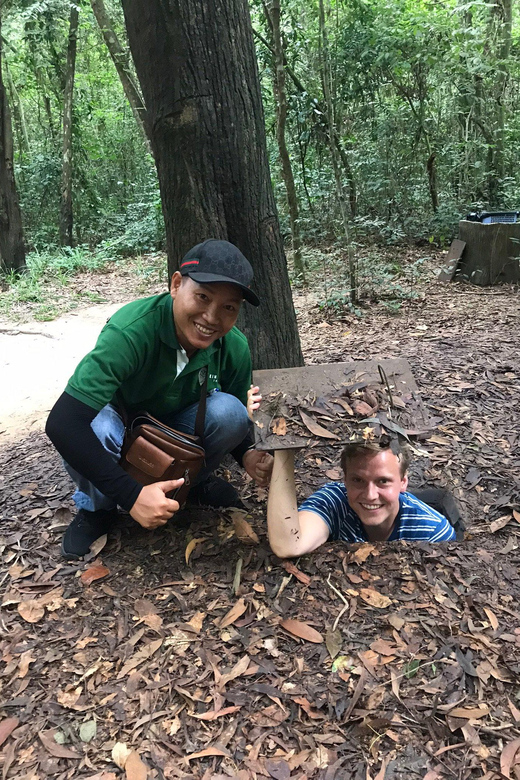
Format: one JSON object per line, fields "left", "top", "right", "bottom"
{"left": 65, "top": 391, "right": 249, "bottom": 512}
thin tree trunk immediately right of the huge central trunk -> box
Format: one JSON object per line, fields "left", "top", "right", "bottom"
{"left": 264, "top": 0, "right": 305, "bottom": 284}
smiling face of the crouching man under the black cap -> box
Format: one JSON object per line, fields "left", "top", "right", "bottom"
{"left": 170, "top": 271, "right": 243, "bottom": 355}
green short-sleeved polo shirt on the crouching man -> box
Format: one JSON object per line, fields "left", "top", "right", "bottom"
{"left": 65, "top": 293, "right": 251, "bottom": 419}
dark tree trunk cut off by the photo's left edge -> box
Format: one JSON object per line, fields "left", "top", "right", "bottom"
{"left": 0, "top": 13, "right": 25, "bottom": 272}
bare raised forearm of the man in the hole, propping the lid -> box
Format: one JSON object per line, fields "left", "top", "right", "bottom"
{"left": 267, "top": 450, "right": 303, "bottom": 558}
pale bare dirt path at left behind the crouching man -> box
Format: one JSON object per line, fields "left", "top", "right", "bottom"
{"left": 0, "top": 303, "right": 129, "bottom": 446}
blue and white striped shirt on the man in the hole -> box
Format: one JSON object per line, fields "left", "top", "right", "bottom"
{"left": 300, "top": 482, "right": 455, "bottom": 542}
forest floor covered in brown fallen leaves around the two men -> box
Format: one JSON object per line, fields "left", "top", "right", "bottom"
{"left": 0, "top": 251, "right": 520, "bottom": 780}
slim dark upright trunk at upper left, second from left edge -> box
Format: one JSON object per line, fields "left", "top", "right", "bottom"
{"left": 60, "top": 6, "right": 79, "bottom": 246}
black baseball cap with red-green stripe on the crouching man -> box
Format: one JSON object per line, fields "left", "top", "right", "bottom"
{"left": 179, "top": 238, "right": 260, "bottom": 306}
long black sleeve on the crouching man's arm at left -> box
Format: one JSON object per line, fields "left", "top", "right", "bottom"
{"left": 45, "top": 393, "right": 142, "bottom": 512}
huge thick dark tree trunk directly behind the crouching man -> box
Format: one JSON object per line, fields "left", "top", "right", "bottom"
{"left": 123, "top": 0, "right": 303, "bottom": 368}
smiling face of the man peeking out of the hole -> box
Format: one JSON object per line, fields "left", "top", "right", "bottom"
{"left": 345, "top": 450, "right": 408, "bottom": 538}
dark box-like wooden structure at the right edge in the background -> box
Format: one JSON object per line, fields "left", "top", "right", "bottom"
{"left": 455, "top": 219, "right": 520, "bottom": 286}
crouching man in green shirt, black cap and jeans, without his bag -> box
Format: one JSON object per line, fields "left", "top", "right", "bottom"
{"left": 46, "top": 239, "right": 272, "bottom": 559}
